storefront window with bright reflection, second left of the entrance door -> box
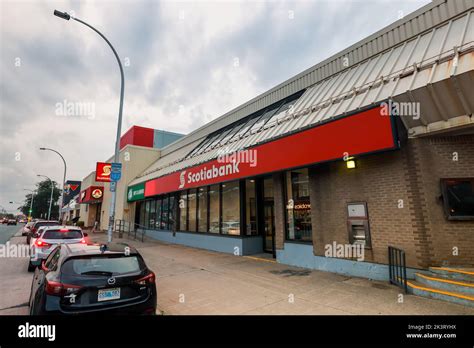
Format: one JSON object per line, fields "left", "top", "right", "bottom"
{"left": 221, "top": 181, "right": 240, "bottom": 235}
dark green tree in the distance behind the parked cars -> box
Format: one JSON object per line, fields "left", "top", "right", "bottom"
{"left": 18, "top": 180, "right": 61, "bottom": 220}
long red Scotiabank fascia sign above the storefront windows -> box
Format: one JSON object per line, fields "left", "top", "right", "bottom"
{"left": 145, "top": 107, "right": 398, "bottom": 197}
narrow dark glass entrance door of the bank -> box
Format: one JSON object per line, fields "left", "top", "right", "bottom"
{"left": 263, "top": 177, "right": 275, "bottom": 257}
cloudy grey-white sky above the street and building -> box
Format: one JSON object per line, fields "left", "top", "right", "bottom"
{"left": 0, "top": 0, "right": 429, "bottom": 211}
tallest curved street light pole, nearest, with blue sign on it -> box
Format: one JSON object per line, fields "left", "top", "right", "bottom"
{"left": 54, "top": 10, "right": 125, "bottom": 243}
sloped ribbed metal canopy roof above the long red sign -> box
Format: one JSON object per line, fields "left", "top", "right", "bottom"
{"left": 131, "top": 9, "right": 474, "bottom": 188}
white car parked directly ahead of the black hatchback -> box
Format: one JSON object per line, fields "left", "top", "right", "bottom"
{"left": 28, "top": 226, "right": 87, "bottom": 272}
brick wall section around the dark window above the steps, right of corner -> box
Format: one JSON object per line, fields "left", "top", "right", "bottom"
{"left": 412, "top": 135, "right": 474, "bottom": 266}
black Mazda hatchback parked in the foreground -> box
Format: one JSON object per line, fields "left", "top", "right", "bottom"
{"left": 30, "top": 244, "right": 156, "bottom": 315}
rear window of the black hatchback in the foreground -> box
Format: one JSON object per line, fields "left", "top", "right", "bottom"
{"left": 63, "top": 255, "right": 143, "bottom": 276}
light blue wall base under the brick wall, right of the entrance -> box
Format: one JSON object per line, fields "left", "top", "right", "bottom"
{"left": 276, "top": 243, "right": 418, "bottom": 281}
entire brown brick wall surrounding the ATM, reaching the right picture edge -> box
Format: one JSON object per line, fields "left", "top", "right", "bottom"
{"left": 274, "top": 135, "right": 474, "bottom": 268}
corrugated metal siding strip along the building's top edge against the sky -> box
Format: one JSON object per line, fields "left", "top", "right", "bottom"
{"left": 157, "top": 0, "right": 474, "bottom": 155}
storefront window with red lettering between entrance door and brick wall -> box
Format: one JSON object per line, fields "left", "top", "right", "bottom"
{"left": 286, "top": 169, "right": 312, "bottom": 241}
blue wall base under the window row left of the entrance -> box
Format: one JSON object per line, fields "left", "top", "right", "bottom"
{"left": 146, "top": 230, "right": 263, "bottom": 255}
